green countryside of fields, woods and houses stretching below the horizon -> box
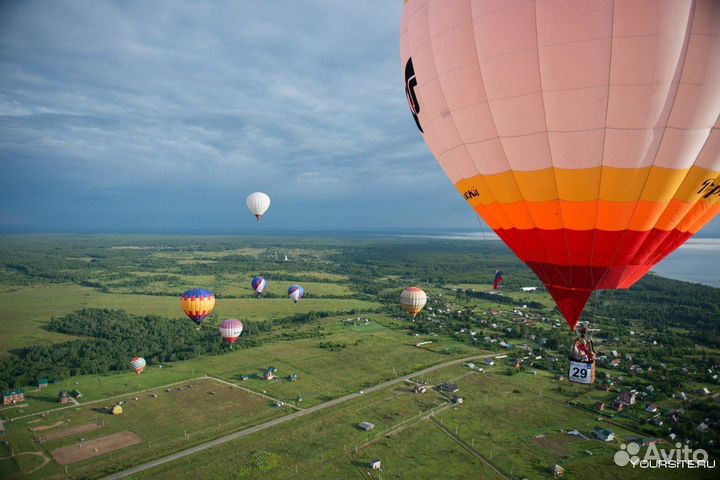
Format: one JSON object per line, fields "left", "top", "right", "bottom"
{"left": 0, "top": 236, "right": 720, "bottom": 479}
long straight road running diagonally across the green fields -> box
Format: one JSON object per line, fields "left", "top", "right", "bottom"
{"left": 103, "top": 354, "right": 495, "bottom": 480}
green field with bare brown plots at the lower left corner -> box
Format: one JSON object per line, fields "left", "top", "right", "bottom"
{"left": 0, "top": 379, "right": 288, "bottom": 478}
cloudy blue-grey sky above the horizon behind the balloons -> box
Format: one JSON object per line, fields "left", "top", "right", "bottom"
{"left": 0, "top": 0, "right": 720, "bottom": 236}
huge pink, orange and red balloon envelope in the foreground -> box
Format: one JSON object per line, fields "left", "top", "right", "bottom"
{"left": 400, "top": 0, "right": 720, "bottom": 328}
